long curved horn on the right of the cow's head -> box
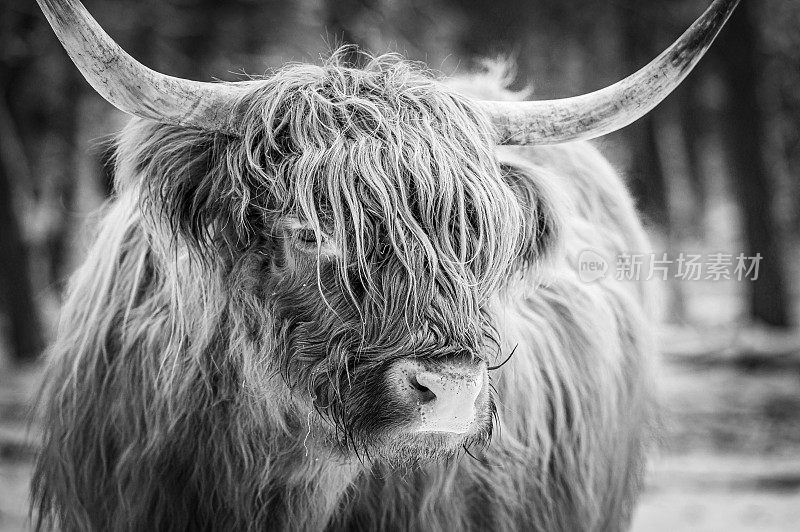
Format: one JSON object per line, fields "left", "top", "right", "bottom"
{"left": 479, "top": 0, "right": 739, "bottom": 145}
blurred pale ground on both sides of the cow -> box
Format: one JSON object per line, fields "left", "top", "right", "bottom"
{"left": 0, "top": 328, "right": 800, "bottom": 532}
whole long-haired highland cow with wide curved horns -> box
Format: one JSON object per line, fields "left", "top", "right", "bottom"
{"left": 32, "top": 0, "right": 736, "bottom": 531}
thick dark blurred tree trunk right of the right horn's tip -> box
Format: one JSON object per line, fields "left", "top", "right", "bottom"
{"left": 716, "top": 1, "right": 790, "bottom": 327}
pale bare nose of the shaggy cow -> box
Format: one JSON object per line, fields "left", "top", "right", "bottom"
{"left": 392, "top": 360, "right": 485, "bottom": 434}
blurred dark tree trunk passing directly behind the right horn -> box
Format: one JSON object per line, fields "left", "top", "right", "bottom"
{"left": 617, "top": 4, "right": 670, "bottom": 232}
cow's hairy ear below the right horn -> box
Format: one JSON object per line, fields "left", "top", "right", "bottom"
{"left": 500, "top": 161, "right": 563, "bottom": 265}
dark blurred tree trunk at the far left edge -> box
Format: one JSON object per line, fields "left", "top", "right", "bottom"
{"left": 0, "top": 112, "right": 44, "bottom": 361}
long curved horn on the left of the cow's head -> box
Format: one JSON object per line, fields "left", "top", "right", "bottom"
{"left": 36, "top": 0, "right": 247, "bottom": 135}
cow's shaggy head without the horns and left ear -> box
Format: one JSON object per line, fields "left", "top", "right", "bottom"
{"left": 243, "top": 57, "right": 554, "bottom": 458}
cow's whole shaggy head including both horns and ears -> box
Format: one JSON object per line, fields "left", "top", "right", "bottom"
{"left": 39, "top": 0, "right": 737, "bottom": 461}
